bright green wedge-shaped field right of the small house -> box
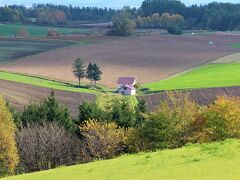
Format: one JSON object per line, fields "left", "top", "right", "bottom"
{"left": 143, "top": 63, "right": 240, "bottom": 92}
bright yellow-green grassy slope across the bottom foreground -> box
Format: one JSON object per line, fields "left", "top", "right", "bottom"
{"left": 6, "top": 140, "right": 240, "bottom": 180}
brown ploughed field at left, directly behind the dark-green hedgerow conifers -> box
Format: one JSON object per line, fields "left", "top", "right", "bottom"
{"left": 0, "top": 80, "right": 96, "bottom": 117}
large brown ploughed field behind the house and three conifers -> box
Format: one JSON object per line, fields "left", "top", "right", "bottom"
{"left": 0, "top": 35, "right": 240, "bottom": 87}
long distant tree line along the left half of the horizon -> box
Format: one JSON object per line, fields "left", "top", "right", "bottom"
{"left": 0, "top": 4, "right": 116, "bottom": 25}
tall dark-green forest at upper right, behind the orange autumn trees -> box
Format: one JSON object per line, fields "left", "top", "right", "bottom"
{"left": 139, "top": 0, "right": 240, "bottom": 31}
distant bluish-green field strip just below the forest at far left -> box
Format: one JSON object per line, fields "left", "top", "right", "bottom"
{"left": 0, "top": 24, "right": 90, "bottom": 37}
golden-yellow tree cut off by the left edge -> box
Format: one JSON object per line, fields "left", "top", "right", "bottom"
{"left": 0, "top": 98, "right": 19, "bottom": 177}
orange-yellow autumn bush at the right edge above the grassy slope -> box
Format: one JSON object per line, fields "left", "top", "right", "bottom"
{"left": 193, "top": 97, "right": 240, "bottom": 142}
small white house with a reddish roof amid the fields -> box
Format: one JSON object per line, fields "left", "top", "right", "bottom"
{"left": 117, "top": 77, "right": 137, "bottom": 95}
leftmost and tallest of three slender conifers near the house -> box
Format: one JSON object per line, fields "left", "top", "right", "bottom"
{"left": 73, "top": 58, "right": 85, "bottom": 86}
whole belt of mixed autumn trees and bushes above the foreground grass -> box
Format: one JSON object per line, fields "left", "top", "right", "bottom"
{"left": 0, "top": 93, "right": 240, "bottom": 176}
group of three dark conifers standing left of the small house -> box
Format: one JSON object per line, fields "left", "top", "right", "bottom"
{"left": 73, "top": 58, "right": 102, "bottom": 86}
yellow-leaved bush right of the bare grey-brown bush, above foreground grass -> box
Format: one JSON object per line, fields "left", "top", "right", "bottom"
{"left": 80, "top": 120, "right": 125, "bottom": 160}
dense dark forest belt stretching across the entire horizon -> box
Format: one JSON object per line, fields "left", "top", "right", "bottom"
{"left": 0, "top": 0, "right": 240, "bottom": 31}
